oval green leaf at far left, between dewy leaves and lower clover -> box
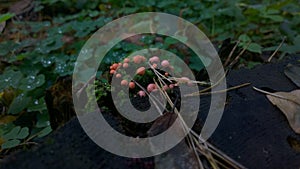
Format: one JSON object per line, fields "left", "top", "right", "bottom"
{"left": 7, "top": 93, "right": 31, "bottom": 114}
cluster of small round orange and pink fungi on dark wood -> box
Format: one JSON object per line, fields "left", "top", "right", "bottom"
{"left": 110, "top": 55, "right": 176, "bottom": 97}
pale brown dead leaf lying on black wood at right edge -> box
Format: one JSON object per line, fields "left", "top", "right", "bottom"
{"left": 267, "top": 90, "right": 300, "bottom": 134}
